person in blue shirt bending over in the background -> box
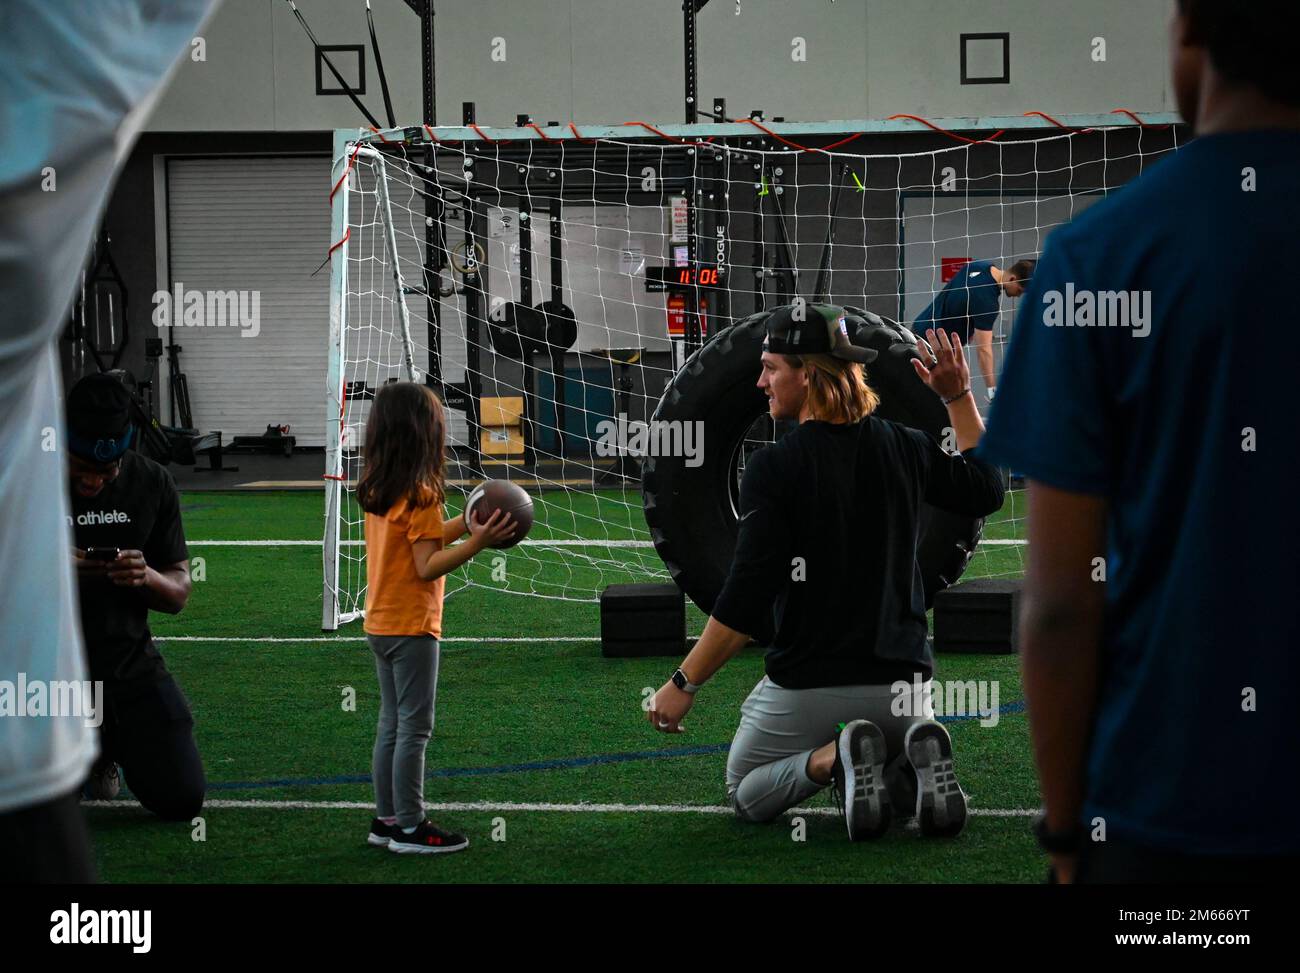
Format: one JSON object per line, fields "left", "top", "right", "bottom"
{"left": 911, "top": 260, "right": 1037, "bottom": 402}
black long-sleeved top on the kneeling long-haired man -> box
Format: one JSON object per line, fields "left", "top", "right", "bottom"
{"left": 712, "top": 416, "right": 1004, "bottom": 689}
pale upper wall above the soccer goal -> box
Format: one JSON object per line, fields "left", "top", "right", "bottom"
{"left": 150, "top": 0, "right": 1173, "bottom": 131}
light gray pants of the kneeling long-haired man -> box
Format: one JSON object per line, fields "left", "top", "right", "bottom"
{"left": 727, "top": 675, "right": 935, "bottom": 821}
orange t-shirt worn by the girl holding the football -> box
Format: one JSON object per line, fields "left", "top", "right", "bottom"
{"left": 365, "top": 500, "right": 445, "bottom": 639}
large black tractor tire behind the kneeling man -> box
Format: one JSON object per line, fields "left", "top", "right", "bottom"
{"left": 641, "top": 307, "right": 984, "bottom": 641}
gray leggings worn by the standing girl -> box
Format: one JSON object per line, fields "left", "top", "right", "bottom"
{"left": 365, "top": 635, "right": 438, "bottom": 827}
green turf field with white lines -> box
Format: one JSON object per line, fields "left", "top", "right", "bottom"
{"left": 90, "top": 492, "right": 1044, "bottom": 882}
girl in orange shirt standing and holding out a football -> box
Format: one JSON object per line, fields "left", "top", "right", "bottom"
{"left": 356, "top": 382, "right": 515, "bottom": 855}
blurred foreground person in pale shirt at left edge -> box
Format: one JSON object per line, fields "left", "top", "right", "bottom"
{"left": 0, "top": 0, "right": 215, "bottom": 882}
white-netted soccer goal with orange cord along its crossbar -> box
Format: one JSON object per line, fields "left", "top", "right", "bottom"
{"left": 322, "top": 113, "right": 1177, "bottom": 630}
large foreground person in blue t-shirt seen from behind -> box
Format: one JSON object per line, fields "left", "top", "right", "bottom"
{"left": 980, "top": 0, "right": 1300, "bottom": 882}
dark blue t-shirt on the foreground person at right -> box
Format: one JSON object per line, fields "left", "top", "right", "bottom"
{"left": 980, "top": 131, "right": 1300, "bottom": 855}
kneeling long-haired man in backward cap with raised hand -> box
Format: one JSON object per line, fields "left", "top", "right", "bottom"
{"left": 649, "top": 303, "right": 1002, "bottom": 840}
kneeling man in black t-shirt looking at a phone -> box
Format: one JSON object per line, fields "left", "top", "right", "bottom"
{"left": 68, "top": 375, "right": 207, "bottom": 821}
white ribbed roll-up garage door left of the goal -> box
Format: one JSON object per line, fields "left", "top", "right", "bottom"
{"left": 164, "top": 156, "right": 330, "bottom": 446}
